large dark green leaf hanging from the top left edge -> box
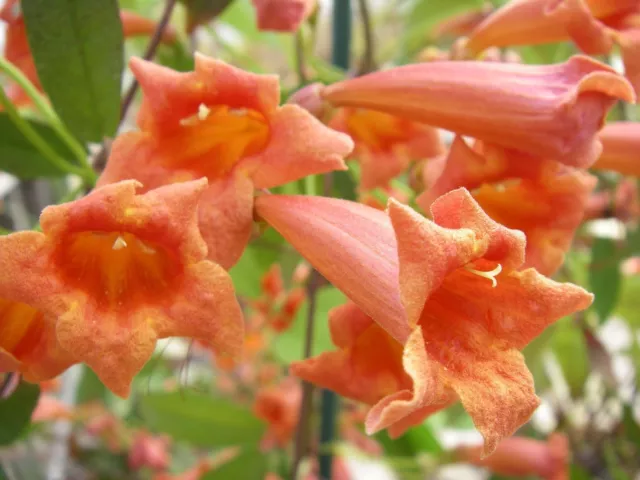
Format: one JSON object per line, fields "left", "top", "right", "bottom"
{"left": 21, "top": 0, "right": 124, "bottom": 142}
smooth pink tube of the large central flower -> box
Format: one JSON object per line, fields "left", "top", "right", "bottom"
{"left": 255, "top": 195, "right": 409, "bottom": 343}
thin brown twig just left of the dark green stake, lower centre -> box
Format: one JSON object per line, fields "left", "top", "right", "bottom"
{"left": 291, "top": 270, "right": 320, "bottom": 480}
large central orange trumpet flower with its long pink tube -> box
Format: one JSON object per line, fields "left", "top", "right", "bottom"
{"left": 256, "top": 189, "right": 593, "bottom": 453}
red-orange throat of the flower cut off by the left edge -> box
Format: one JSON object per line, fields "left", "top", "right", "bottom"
{"left": 0, "top": 298, "right": 44, "bottom": 360}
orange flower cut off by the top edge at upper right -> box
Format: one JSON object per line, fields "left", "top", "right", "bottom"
{"left": 466, "top": 0, "right": 636, "bottom": 55}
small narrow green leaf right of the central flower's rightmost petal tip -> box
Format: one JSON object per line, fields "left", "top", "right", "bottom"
{"left": 589, "top": 238, "right": 622, "bottom": 322}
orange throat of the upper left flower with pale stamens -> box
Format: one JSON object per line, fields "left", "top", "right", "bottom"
{"left": 161, "top": 104, "right": 269, "bottom": 180}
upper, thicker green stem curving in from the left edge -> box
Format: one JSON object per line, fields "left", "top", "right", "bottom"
{"left": 0, "top": 57, "right": 91, "bottom": 173}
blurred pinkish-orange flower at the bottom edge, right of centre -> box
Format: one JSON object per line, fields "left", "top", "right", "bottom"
{"left": 455, "top": 433, "right": 569, "bottom": 480}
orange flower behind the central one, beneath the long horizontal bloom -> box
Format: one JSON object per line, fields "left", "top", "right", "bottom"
{"left": 417, "top": 137, "right": 597, "bottom": 275}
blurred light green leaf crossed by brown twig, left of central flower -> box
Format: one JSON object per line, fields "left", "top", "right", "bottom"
{"left": 273, "top": 287, "right": 346, "bottom": 363}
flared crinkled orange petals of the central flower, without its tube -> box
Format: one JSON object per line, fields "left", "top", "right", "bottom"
{"left": 389, "top": 193, "right": 593, "bottom": 454}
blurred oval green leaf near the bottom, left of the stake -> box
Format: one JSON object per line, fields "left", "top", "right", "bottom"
{"left": 140, "top": 391, "right": 265, "bottom": 447}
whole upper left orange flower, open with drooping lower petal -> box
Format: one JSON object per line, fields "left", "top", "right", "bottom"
{"left": 98, "top": 54, "right": 353, "bottom": 268}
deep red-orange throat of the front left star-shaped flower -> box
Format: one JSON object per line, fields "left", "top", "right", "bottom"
{"left": 57, "top": 232, "right": 182, "bottom": 309}
